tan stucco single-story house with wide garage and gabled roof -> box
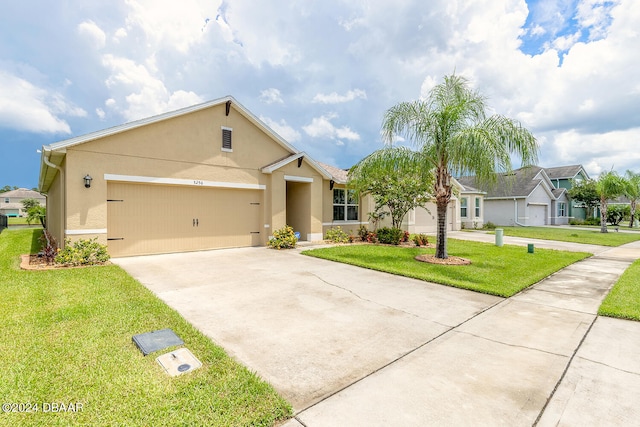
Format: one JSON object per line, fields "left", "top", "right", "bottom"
{"left": 39, "top": 96, "right": 366, "bottom": 256}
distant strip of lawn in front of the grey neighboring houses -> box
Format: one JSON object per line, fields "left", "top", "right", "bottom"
{"left": 488, "top": 227, "right": 640, "bottom": 246}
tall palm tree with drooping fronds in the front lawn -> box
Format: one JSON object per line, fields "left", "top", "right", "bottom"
{"left": 382, "top": 74, "right": 538, "bottom": 258}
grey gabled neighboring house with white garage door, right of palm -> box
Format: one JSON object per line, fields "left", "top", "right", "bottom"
{"left": 458, "top": 166, "right": 569, "bottom": 226}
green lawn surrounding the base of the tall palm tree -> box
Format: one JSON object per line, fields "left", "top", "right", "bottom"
{"left": 302, "top": 239, "right": 591, "bottom": 297}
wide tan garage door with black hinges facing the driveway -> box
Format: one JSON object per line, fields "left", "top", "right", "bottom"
{"left": 107, "top": 183, "right": 264, "bottom": 257}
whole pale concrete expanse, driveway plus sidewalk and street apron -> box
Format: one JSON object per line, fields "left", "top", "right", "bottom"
{"left": 114, "top": 239, "right": 640, "bottom": 427}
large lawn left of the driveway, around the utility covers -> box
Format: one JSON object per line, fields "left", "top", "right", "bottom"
{"left": 0, "top": 229, "right": 292, "bottom": 426}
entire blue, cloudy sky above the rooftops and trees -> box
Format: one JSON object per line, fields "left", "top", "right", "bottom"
{"left": 0, "top": 0, "right": 640, "bottom": 188}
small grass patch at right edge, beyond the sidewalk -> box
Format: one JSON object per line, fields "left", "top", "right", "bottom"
{"left": 598, "top": 260, "right": 640, "bottom": 321}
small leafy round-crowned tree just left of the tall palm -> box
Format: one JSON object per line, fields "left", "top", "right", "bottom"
{"left": 347, "top": 147, "right": 433, "bottom": 228}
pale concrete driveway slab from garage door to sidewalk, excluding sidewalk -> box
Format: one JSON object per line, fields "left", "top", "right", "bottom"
{"left": 114, "top": 248, "right": 502, "bottom": 412}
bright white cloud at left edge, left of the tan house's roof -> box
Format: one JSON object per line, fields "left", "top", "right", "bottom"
{"left": 0, "top": 70, "right": 86, "bottom": 134}
